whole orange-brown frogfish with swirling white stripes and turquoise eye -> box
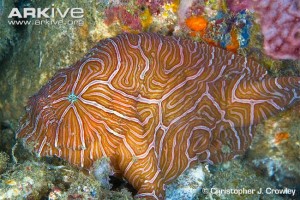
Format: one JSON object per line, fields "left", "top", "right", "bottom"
{"left": 17, "top": 33, "right": 300, "bottom": 199}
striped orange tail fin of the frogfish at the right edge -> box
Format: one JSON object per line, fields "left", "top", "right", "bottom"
{"left": 227, "top": 76, "right": 300, "bottom": 127}
